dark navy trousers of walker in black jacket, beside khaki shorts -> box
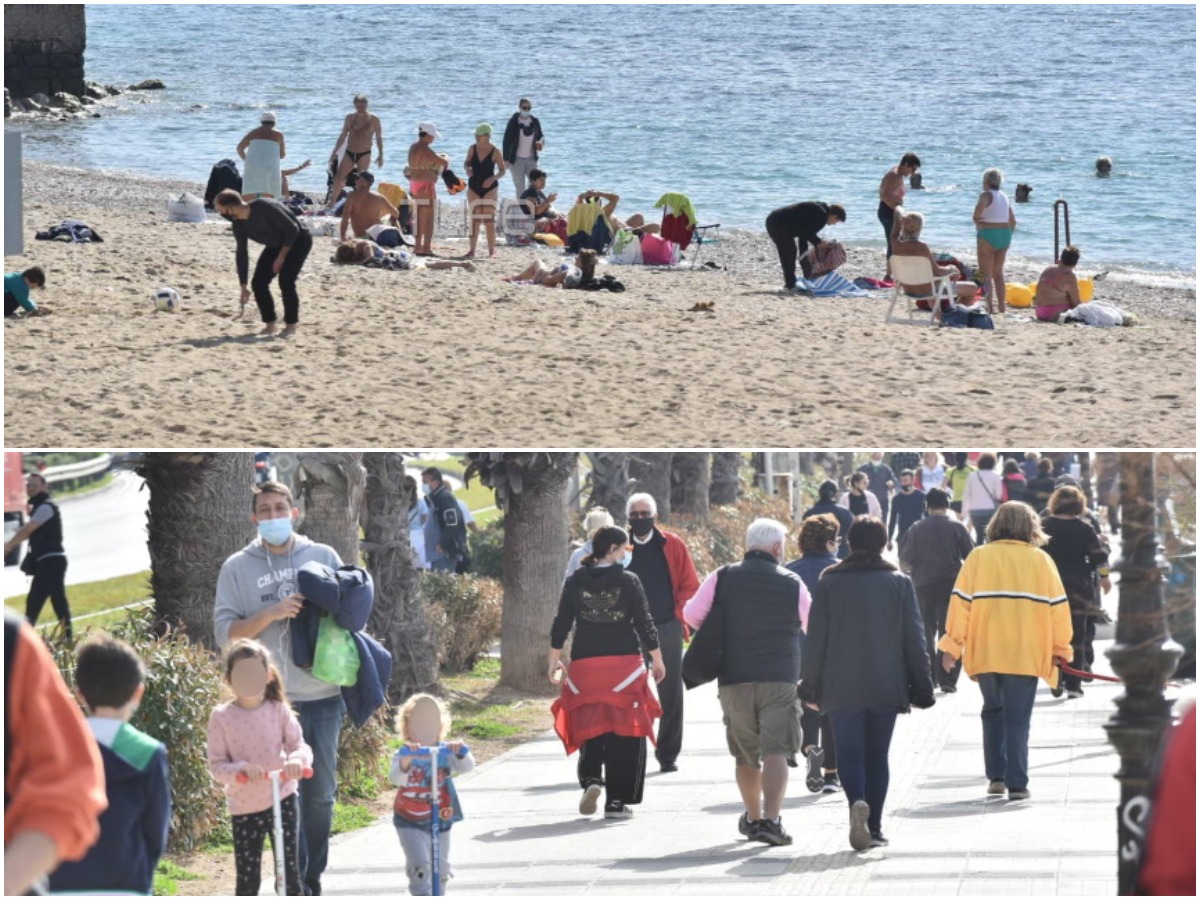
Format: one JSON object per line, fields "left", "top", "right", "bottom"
{"left": 829, "top": 707, "right": 900, "bottom": 834}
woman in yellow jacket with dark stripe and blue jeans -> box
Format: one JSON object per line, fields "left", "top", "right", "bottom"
{"left": 937, "top": 502, "right": 1072, "bottom": 800}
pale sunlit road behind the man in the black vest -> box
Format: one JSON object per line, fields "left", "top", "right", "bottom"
{"left": 4, "top": 472, "right": 150, "bottom": 596}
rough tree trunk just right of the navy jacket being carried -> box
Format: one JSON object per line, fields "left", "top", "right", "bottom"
{"left": 361, "top": 452, "right": 438, "bottom": 706}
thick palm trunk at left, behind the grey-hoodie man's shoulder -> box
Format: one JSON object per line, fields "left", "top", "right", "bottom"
{"left": 137, "top": 452, "right": 254, "bottom": 649}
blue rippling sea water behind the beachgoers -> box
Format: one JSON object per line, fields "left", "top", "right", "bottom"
{"left": 11, "top": 4, "right": 1196, "bottom": 284}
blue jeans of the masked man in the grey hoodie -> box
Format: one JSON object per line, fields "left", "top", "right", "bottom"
{"left": 292, "top": 694, "right": 346, "bottom": 884}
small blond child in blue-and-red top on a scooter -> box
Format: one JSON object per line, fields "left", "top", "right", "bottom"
{"left": 389, "top": 694, "right": 475, "bottom": 896}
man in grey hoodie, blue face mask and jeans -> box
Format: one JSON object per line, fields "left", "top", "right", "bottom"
{"left": 212, "top": 481, "right": 346, "bottom": 894}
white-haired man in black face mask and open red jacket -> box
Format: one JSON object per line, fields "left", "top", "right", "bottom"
{"left": 625, "top": 493, "right": 700, "bottom": 772}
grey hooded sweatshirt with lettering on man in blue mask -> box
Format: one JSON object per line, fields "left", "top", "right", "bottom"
{"left": 212, "top": 534, "right": 342, "bottom": 700}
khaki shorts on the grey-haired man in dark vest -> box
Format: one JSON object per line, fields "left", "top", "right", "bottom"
{"left": 718, "top": 682, "right": 802, "bottom": 769}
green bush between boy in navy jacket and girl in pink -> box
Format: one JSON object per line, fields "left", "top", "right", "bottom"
{"left": 52, "top": 608, "right": 226, "bottom": 851}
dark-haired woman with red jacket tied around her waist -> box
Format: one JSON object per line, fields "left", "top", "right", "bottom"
{"left": 550, "top": 527, "right": 666, "bottom": 818}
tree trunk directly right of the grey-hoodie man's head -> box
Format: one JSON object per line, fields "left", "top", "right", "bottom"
{"left": 299, "top": 452, "right": 366, "bottom": 565}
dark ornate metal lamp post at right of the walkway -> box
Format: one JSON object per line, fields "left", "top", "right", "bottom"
{"left": 1104, "top": 454, "right": 1181, "bottom": 895}
